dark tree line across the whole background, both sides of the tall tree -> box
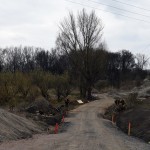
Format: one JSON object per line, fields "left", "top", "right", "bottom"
{"left": 0, "top": 45, "right": 147, "bottom": 97}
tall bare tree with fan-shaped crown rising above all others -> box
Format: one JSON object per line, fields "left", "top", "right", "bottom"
{"left": 56, "top": 9, "right": 103, "bottom": 99}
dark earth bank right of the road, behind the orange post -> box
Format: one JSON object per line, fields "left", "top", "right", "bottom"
{"left": 116, "top": 100, "right": 150, "bottom": 142}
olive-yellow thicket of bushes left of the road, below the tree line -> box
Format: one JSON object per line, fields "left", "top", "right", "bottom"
{"left": 0, "top": 71, "right": 70, "bottom": 108}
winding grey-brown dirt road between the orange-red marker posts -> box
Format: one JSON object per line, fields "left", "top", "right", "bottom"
{"left": 0, "top": 95, "right": 150, "bottom": 150}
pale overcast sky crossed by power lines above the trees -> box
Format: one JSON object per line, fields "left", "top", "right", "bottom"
{"left": 0, "top": 0, "right": 150, "bottom": 55}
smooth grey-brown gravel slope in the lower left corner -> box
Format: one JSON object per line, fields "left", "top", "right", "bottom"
{"left": 0, "top": 109, "right": 42, "bottom": 142}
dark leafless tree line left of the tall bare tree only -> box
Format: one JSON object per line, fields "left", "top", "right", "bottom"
{"left": 0, "top": 46, "right": 67, "bottom": 74}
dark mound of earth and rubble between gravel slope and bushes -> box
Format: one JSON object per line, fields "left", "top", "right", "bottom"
{"left": 26, "top": 97, "right": 65, "bottom": 126}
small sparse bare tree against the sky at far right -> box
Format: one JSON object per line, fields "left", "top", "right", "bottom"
{"left": 135, "top": 54, "right": 149, "bottom": 70}
